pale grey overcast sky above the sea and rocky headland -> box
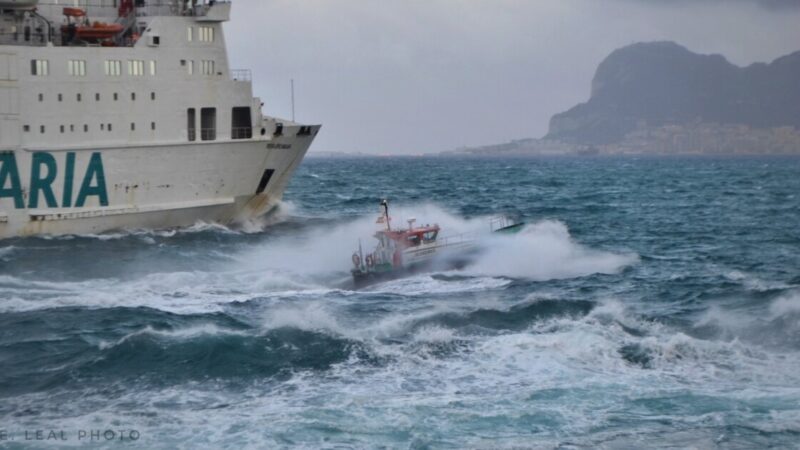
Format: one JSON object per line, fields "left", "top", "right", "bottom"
{"left": 226, "top": 0, "right": 800, "bottom": 154}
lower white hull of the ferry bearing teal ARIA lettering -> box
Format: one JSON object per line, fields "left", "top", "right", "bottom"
{"left": 0, "top": 127, "right": 318, "bottom": 239}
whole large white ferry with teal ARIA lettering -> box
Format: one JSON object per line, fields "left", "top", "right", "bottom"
{"left": 0, "top": 0, "right": 320, "bottom": 238}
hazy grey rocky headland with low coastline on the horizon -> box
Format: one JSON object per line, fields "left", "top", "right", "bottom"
{"left": 444, "top": 42, "right": 800, "bottom": 156}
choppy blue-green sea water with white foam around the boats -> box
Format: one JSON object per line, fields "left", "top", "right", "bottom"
{"left": 0, "top": 158, "right": 800, "bottom": 449}
